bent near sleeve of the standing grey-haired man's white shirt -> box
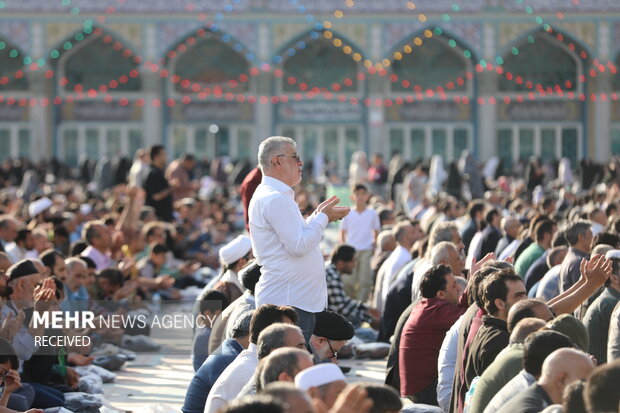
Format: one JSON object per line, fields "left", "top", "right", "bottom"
{"left": 265, "top": 196, "right": 328, "bottom": 257}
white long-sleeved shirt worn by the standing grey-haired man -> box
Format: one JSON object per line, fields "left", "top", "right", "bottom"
{"left": 249, "top": 176, "right": 328, "bottom": 313}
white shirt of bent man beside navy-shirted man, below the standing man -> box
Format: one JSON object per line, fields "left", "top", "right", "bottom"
{"left": 204, "top": 343, "right": 258, "bottom": 413}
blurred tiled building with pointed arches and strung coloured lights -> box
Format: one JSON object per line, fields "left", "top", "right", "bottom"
{"left": 0, "top": 0, "right": 620, "bottom": 173}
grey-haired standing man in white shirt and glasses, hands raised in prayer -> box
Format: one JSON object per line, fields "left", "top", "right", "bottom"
{"left": 249, "top": 136, "right": 349, "bottom": 341}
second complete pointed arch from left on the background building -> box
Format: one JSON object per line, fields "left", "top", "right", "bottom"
{"left": 165, "top": 28, "right": 253, "bottom": 94}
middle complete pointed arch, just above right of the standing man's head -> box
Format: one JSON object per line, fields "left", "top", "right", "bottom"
{"left": 273, "top": 30, "right": 363, "bottom": 92}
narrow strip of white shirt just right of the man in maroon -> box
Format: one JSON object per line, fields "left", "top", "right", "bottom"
{"left": 437, "top": 316, "right": 463, "bottom": 412}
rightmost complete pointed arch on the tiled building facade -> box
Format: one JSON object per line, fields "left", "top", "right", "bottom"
{"left": 498, "top": 29, "right": 590, "bottom": 92}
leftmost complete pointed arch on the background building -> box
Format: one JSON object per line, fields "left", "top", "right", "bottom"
{"left": 50, "top": 27, "right": 142, "bottom": 93}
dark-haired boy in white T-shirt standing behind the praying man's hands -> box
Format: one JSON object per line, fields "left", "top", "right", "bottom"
{"left": 340, "top": 184, "right": 381, "bottom": 302}
